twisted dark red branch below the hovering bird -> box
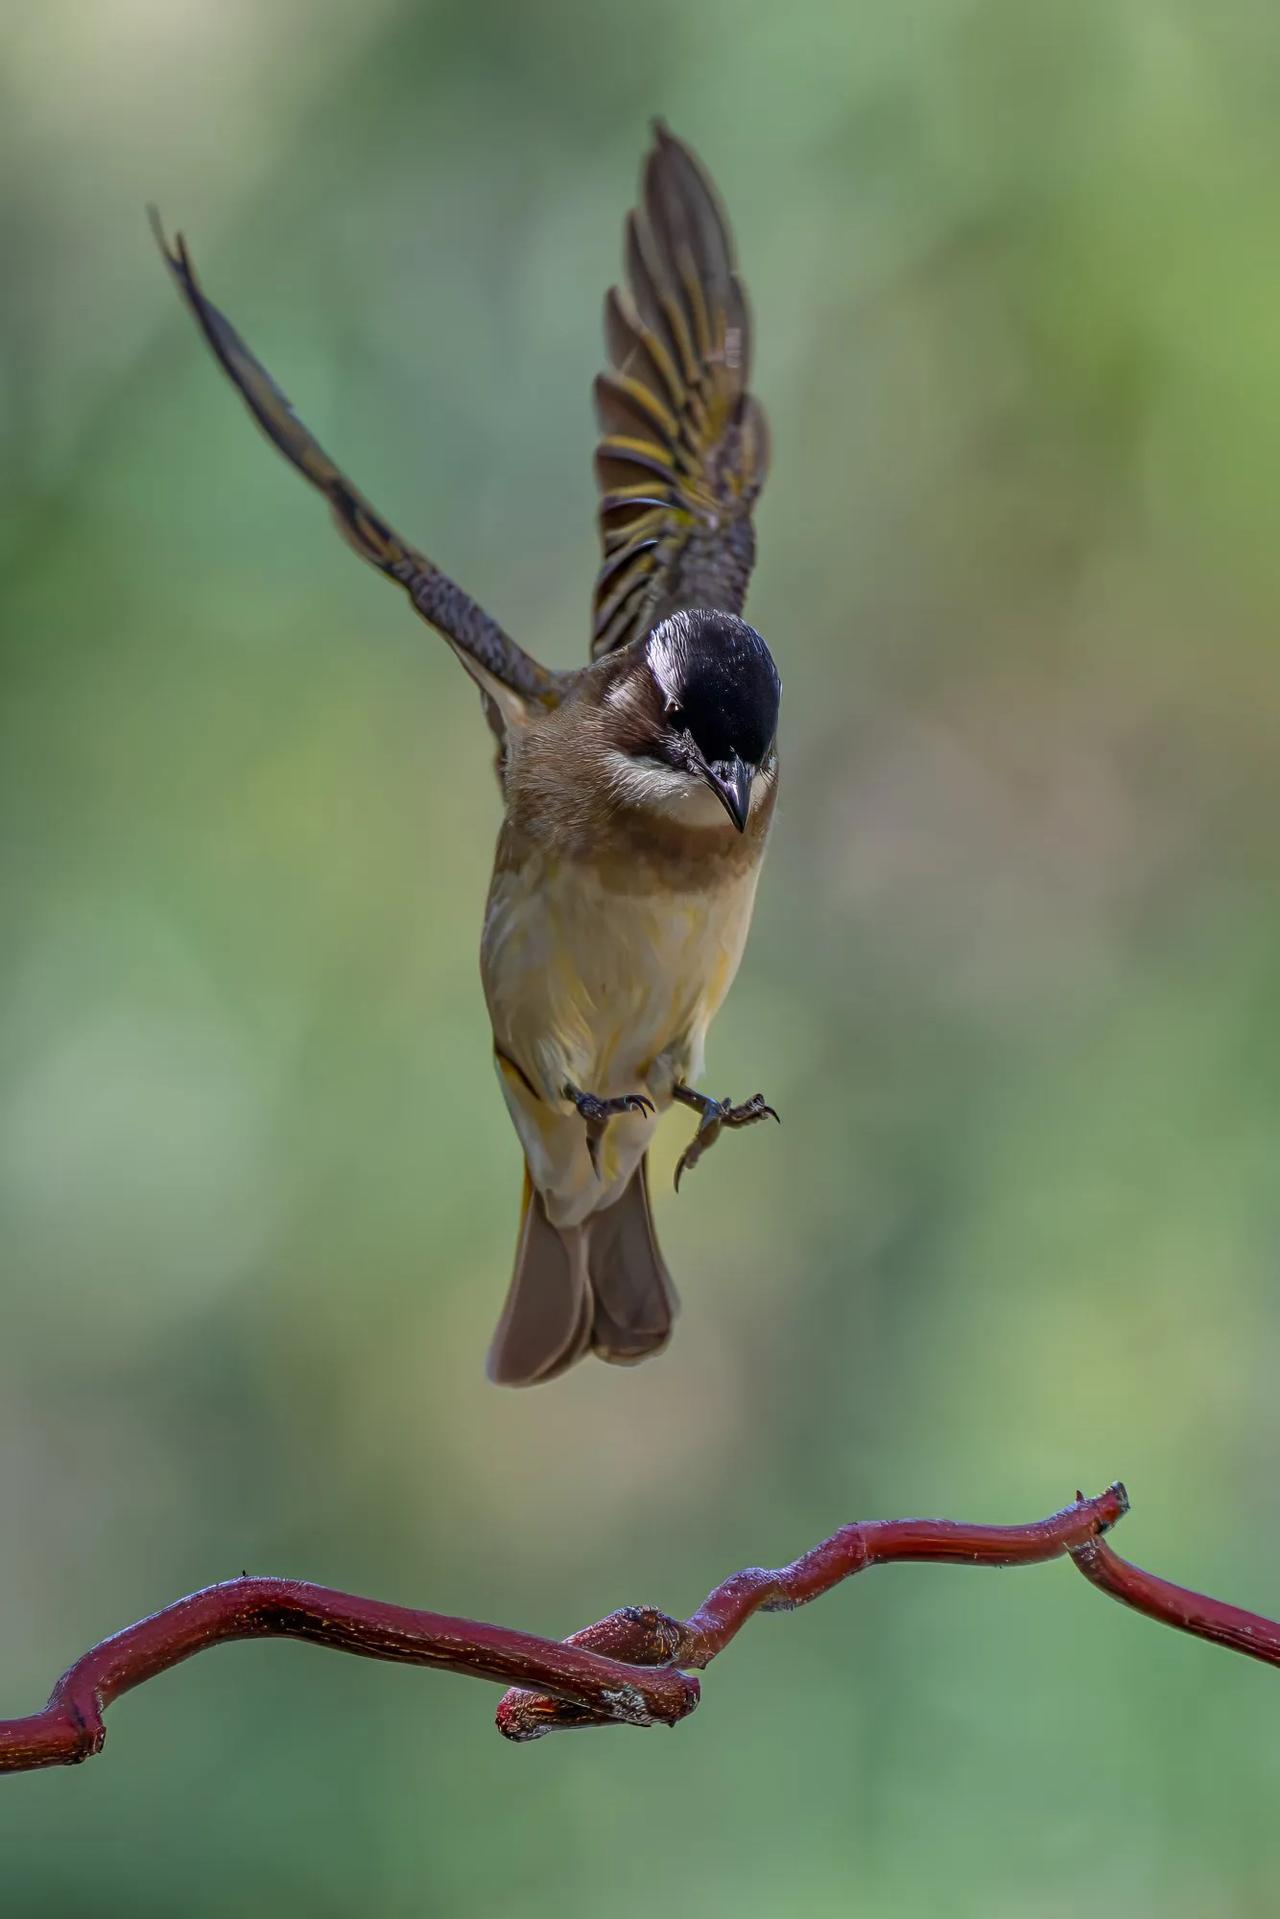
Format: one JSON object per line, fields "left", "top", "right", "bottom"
{"left": 0, "top": 1485, "right": 1280, "bottom": 1771}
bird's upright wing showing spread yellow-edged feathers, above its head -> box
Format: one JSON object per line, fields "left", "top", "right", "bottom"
{"left": 591, "top": 121, "right": 768, "bottom": 656}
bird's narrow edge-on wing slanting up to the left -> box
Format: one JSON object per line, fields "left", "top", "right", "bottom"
{"left": 152, "top": 211, "right": 560, "bottom": 731}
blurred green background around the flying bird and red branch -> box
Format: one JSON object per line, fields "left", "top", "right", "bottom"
{"left": 0, "top": 0, "right": 1280, "bottom": 1919}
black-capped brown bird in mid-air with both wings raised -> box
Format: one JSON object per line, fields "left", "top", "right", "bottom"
{"left": 154, "top": 123, "right": 779, "bottom": 1386}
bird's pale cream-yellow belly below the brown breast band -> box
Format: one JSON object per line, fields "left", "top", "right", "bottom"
{"left": 482, "top": 852, "right": 758, "bottom": 1226}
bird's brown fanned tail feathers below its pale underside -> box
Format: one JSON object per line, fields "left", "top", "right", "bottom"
{"left": 487, "top": 1159, "right": 679, "bottom": 1386}
